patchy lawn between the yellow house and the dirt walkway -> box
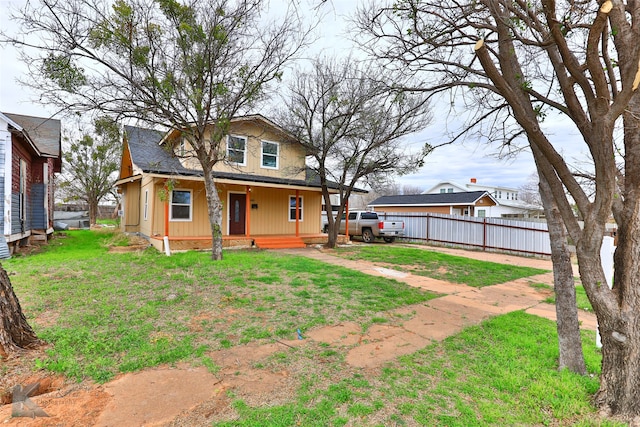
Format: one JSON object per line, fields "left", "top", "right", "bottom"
{"left": 3, "top": 230, "right": 436, "bottom": 381}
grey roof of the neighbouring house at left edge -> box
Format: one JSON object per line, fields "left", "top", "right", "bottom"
{"left": 2, "top": 113, "right": 62, "bottom": 158}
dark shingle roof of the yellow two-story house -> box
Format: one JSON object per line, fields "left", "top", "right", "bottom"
{"left": 120, "top": 123, "right": 367, "bottom": 193}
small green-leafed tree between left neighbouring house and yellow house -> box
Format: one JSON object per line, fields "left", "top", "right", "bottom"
{"left": 58, "top": 117, "right": 122, "bottom": 224}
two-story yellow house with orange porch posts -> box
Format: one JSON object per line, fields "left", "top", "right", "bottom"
{"left": 116, "top": 115, "right": 340, "bottom": 250}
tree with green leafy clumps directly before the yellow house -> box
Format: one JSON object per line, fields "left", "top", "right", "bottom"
{"left": 4, "top": 0, "right": 309, "bottom": 259}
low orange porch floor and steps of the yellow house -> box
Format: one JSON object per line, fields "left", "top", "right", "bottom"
{"left": 149, "top": 233, "right": 347, "bottom": 252}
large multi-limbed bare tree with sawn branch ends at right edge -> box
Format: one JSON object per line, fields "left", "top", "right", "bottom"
{"left": 358, "top": 0, "right": 640, "bottom": 420}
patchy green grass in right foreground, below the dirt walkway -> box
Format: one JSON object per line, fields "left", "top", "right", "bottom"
{"left": 214, "top": 312, "right": 619, "bottom": 427}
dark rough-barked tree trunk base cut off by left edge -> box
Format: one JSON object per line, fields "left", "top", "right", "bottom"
{"left": 0, "top": 266, "right": 41, "bottom": 357}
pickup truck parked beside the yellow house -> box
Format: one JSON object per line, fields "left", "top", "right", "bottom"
{"left": 339, "top": 211, "right": 404, "bottom": 243}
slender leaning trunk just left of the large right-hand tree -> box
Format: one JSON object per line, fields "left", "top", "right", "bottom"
{"left": 539, "top": 173, "right": 587, "bottom": 375}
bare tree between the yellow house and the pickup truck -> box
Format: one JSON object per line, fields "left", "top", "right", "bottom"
{"left": 279, "top": 58, "right": 430, "bottom": 247}
